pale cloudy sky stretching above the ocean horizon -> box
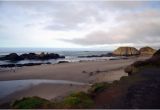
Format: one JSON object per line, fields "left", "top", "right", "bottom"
{"left": 0, "top": 0, "right": 160, "bottom": 50}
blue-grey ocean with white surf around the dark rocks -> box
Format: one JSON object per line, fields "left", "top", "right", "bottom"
{"left": 0, "top": 48, "right": 113, "bottom": 65}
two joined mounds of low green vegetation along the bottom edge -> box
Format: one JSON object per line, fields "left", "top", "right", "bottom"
{"left": 11, "top": 92, "right": 94, "bottom": 109}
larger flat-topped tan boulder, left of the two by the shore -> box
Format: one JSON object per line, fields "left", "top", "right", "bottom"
{"left": 113, "top": 47, "right": 140, "bottom": 56}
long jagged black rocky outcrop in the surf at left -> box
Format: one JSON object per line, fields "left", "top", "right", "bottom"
{"left": 0, "top": 52, "right": 65, "bottom": 61}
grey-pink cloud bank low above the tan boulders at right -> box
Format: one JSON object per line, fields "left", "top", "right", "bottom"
{"left": 63, "top": 10, "right": 160, "bottom": 45}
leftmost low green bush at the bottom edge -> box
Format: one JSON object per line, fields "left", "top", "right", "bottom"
{"left": 12, "top": 97, "right": 50, "bottom": 109}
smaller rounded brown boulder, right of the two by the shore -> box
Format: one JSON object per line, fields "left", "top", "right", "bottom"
{"left": 139, "top": 46, "right": 156, "bottom": 56}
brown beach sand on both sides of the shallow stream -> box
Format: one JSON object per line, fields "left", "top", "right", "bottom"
{"left": 0, "top": 58, "right": 149, "bottom": 102}
